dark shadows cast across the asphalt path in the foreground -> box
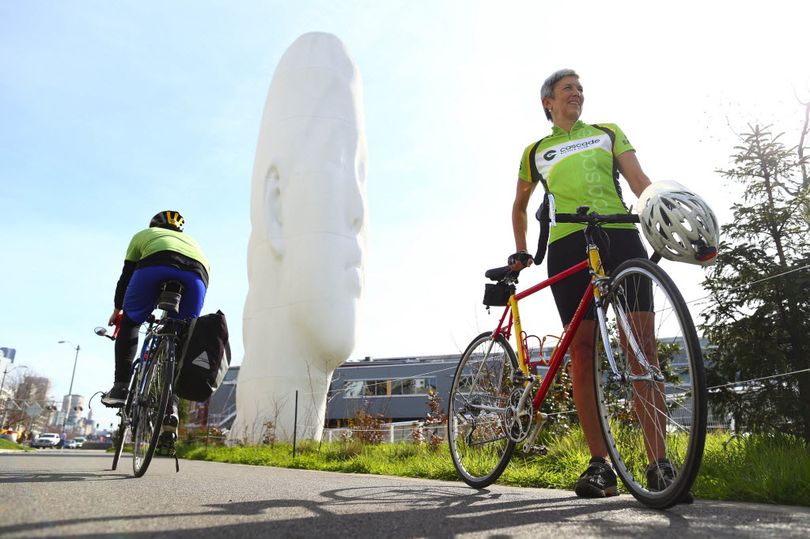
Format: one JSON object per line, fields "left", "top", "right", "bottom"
{"left": 0, "top": 480, "right": 784, "bottom": 538}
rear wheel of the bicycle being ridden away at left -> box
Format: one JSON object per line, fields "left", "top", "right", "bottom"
{"left": 132, "top": 337, "right": 174, "bottom": 477}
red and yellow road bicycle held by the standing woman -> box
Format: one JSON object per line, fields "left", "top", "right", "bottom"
{"left": 447, "top": 208, "right": 706, "bottom": 508}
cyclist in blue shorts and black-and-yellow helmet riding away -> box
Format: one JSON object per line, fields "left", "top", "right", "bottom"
{"left": 101, "top": 210, "right": 210, "bottom": 454}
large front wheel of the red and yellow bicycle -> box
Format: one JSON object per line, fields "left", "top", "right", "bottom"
{"left": 593, "top": 259, "right": 707, "bottom": 509}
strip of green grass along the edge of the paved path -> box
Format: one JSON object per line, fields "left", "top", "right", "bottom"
{"left": 177, "top": 429, "right": 810, "bottom": 506}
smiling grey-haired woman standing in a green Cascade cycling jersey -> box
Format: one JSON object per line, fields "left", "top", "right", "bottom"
{"left": 509, "top": 69, "right": 704, "bottom": 498}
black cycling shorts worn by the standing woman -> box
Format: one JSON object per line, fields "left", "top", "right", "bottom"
{"left": 548, "top": 228, "right": 652, "bottom": 326}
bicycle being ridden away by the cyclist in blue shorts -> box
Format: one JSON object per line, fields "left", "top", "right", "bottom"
{"left": 96, "top": 281, "right": 187, "bottom": 477}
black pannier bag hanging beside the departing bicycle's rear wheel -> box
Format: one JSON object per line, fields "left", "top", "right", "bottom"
{"left": 174, "top": 311, "right": 231, "bottom": 402}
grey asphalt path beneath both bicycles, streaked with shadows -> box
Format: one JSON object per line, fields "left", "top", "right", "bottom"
{"left": 0, "top": 449, "right": 810, "bottom": 539}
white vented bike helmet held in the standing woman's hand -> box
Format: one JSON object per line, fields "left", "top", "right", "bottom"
{"left": 638, "top": 181, "right": 720, "bottom": 266}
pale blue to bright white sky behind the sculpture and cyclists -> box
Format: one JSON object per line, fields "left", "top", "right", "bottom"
{"left": 0, "top": 0, "right": 810, "bottom": 427}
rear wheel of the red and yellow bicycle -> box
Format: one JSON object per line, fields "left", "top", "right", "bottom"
{"left": 447, "top": 332, "right": 518, "bottom": 489}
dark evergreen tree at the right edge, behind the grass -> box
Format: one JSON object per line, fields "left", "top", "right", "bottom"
{"left": 702, "top": 105, "right": 810, "bottom": 444}
